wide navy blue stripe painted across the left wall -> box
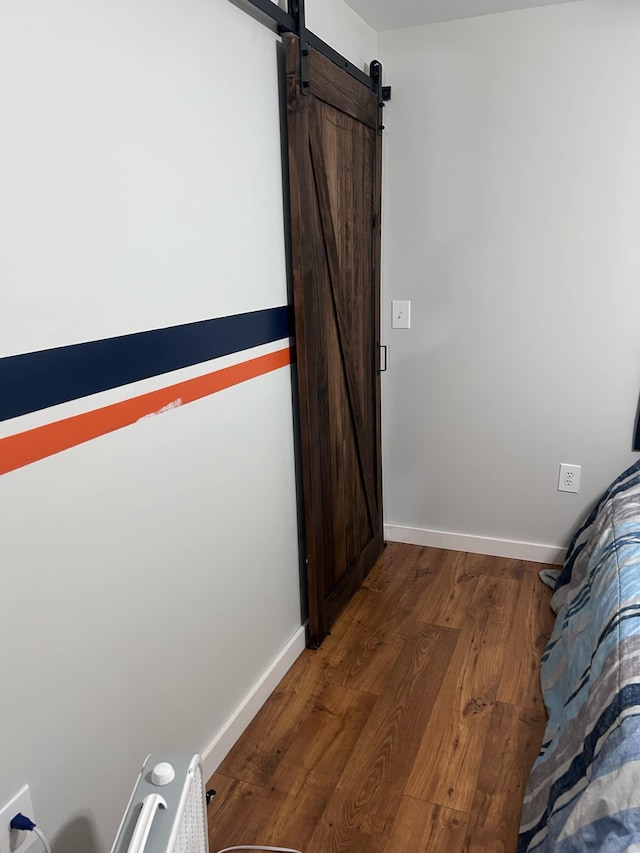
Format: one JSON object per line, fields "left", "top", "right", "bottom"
{"left": 0, "top": 306, "right": 290, "bottom": 421}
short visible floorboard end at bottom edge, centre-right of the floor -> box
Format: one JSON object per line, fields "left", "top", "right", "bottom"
{"left": 384, "top": 797, "right": 469, "bottom": 853}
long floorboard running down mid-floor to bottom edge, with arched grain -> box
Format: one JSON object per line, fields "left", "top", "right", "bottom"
{"left": 307, "top": 625, "right": 458, "bottom": 853}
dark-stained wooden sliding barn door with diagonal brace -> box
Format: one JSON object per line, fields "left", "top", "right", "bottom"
{"left": 285, "top": 36, "right": 383, "bottom": 646}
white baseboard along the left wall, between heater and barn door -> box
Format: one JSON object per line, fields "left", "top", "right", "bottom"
{"left": 202, "top": 625, "right": 305, "bottom": 779}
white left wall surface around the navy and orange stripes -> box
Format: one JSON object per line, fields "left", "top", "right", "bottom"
{"left": 0, "top": 0, "right": 375, "bottom": 853}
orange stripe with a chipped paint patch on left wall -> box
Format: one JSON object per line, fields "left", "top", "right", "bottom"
{"left": 0, "top": 347, "right": 291, "bottom": 475}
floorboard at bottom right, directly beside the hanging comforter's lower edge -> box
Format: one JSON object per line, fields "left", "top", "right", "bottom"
{"left": 463, "top": 702, "right": 546, "bottom": 853}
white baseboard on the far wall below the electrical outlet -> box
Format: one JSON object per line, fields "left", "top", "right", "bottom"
{"left": 384, "top": 524, "right": 567, "bottom": 566}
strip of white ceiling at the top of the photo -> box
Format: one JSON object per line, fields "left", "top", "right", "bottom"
{"left": 346, "top": 0, "right": 577, "bottom": 32}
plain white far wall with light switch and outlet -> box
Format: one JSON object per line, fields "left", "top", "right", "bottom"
{"left": 379, "top": 0, "right": 640, "bottom": 555}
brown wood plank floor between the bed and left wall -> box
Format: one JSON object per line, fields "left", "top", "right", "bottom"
{"left": 208, "top": 543, "right": 553, "bottom": 853}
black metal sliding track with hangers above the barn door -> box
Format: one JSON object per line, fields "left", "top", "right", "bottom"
{"left": 232, "top": 0, "right": 391, "bottom": 134}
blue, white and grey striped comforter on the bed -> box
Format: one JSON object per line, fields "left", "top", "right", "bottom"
{"left": 518, "top": 462, "right": 640, "bottom": 853}
